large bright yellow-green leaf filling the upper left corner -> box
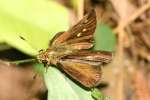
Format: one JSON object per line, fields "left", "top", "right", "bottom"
{"left": 0, "top": 0, "right": 69, "bottom": 56}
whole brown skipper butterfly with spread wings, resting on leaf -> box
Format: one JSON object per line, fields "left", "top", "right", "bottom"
{"left": 37, "top": 10, "right": 112, "bottom": 87}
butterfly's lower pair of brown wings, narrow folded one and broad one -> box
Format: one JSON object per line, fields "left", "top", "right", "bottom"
{"left": 58, "top": 50, "right": 112, "bottom": 87}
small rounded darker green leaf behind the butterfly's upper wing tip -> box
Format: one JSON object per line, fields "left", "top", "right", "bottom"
{"left": 94, "top": 24, "right": 116, "bottom": 51}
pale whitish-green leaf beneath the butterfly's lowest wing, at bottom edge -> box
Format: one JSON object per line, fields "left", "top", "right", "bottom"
{"left": 44, "top": 67, "right": 94, "bottom": 100}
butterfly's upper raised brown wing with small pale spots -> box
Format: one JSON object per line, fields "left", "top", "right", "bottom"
{"left": 50, "top": 10, "right": 96, "bottom": 46}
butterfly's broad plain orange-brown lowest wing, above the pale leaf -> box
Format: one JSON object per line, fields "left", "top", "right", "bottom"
{"left": 58, "top": 59, "right": 101, "bottom": 87}
